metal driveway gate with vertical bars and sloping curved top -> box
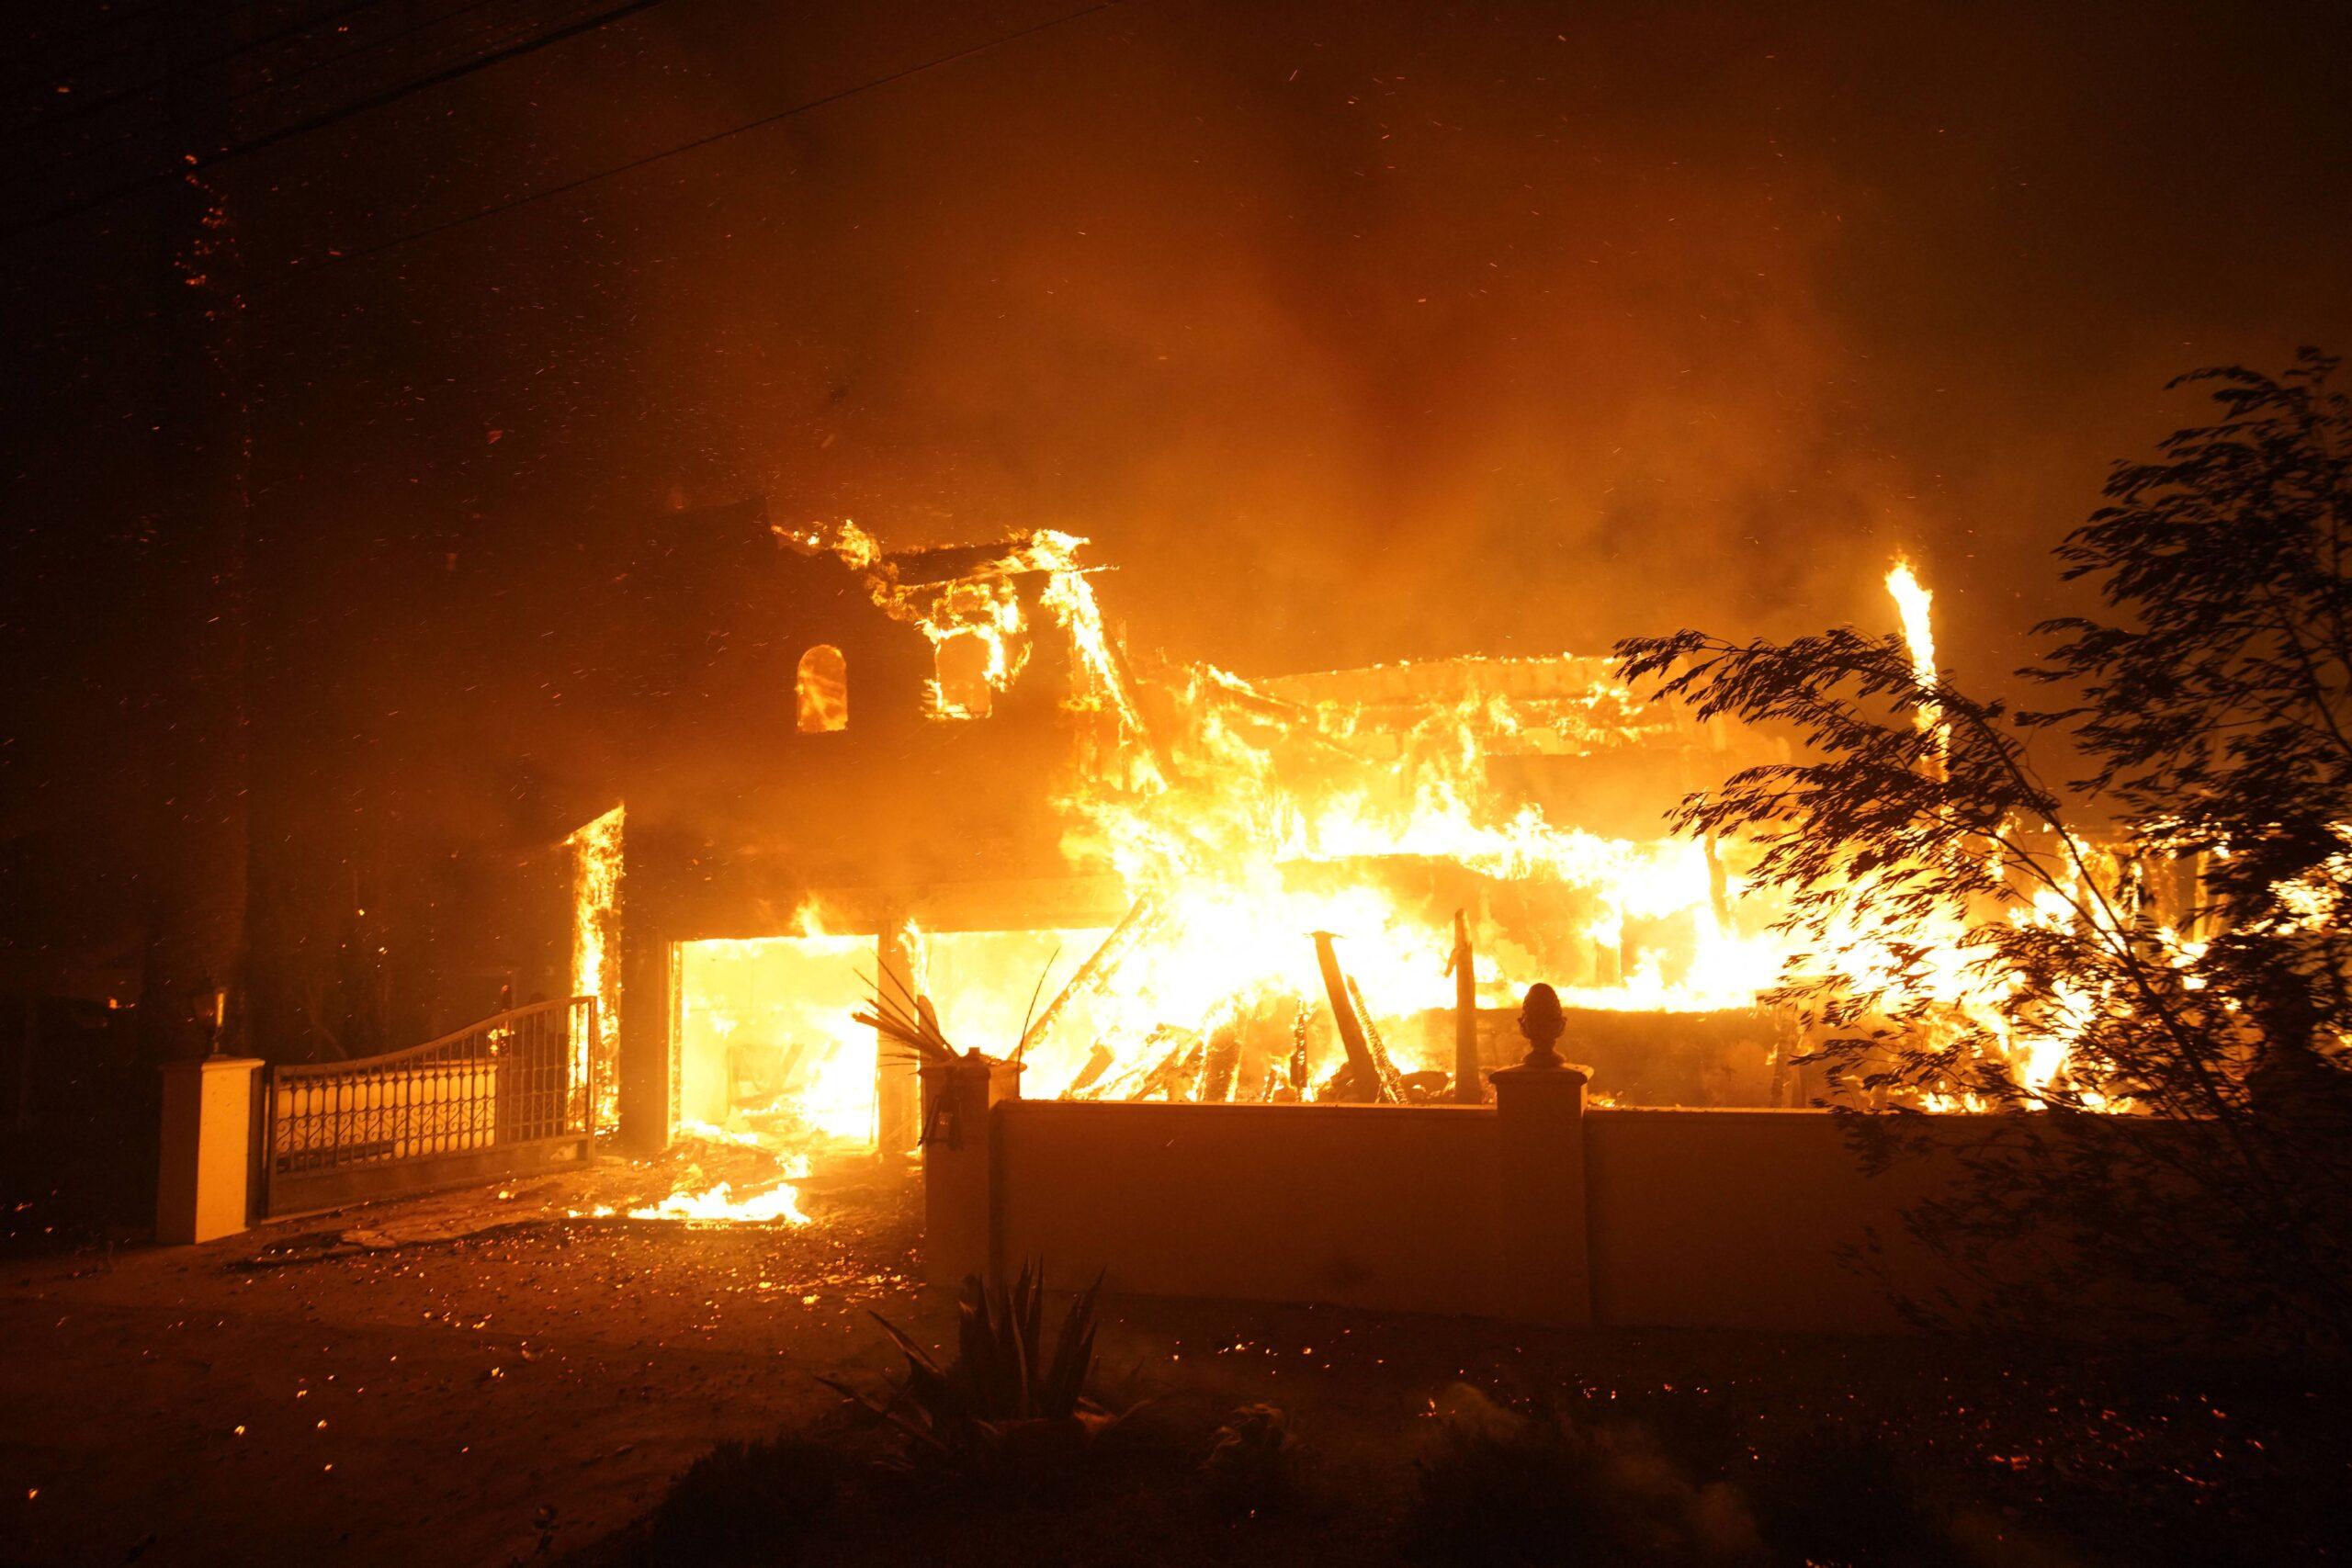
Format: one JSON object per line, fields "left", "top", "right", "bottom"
{"left": 261, "top": 997, "right": 597, "bottom": 1213}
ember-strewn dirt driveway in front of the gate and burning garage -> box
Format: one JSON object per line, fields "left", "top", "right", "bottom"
{"left": 0, "top": 1185, "right": 938, "bottom": 1565}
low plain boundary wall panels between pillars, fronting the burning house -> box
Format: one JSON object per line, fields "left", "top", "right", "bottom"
{"left": 990, "top": 1100, "right": 1987, "bottom": 1333}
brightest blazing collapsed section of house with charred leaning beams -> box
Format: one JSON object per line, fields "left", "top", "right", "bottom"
{"left": 1025, "top": 639, "right": 1773, "bottom": 1100}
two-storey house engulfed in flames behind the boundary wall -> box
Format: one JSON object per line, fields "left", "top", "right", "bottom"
{"left": 555, "top": 525, "right": 1806, "bottom": 1166}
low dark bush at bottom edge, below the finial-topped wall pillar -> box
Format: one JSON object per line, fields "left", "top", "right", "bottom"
{"left": 1404, "top": 1387, "right": 1759, "bottom": 1568}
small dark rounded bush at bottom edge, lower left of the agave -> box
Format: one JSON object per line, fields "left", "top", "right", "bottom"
{"left": 647, "top": 1438, "right": 849, "bottom": 1568}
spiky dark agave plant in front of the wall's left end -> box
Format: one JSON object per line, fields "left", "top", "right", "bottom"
{"left": 823, "top": 1265, "right": 1126, "bottom": 1464}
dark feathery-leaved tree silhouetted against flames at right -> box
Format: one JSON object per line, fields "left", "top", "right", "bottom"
{"left": 1618, "top": 350, "right": 2352, "bottom": 1349}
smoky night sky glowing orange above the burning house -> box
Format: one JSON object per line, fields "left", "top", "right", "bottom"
{"left": 0, "top": 0, "right": 2352, "bottom": 869}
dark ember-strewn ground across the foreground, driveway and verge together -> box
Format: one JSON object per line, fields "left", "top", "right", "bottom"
{"left": 0, "top": 1156, "right": 2352, "bottom": 1568}
